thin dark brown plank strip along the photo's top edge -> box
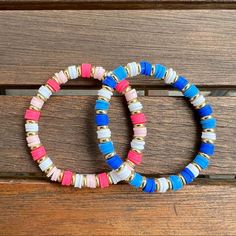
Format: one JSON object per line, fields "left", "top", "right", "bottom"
{"left": 0, "top": 0, "right": 236, "bottom": 10}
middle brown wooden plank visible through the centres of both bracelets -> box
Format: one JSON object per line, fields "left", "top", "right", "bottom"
{"left": 0, "top": 96, "right": 236, "bottom": 175}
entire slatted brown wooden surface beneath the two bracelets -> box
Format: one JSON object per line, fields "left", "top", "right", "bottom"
{"left": 0, "top": 3, "right": 236, "bottom": 236}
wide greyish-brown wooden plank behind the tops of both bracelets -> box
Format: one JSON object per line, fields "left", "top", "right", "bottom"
{"left": 0, "top": 10, "right": 236, "bottom": 87}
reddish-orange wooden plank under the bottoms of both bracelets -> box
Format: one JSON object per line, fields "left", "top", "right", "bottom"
{"left": 0, "top": 181, "right": 236, "bottom": 236}
